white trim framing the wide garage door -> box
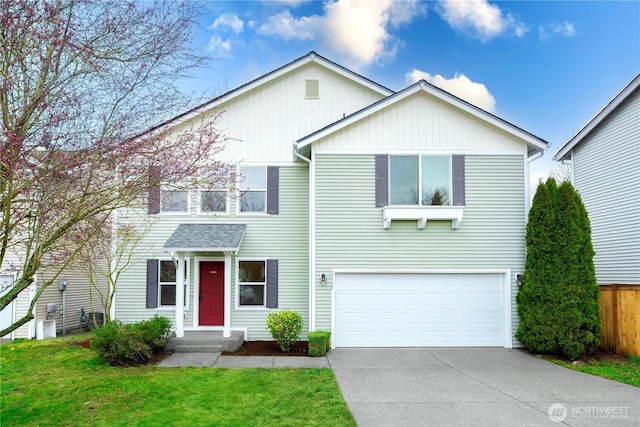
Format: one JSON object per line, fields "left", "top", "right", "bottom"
{"left": 331, "top": 268, "right": 513, "bottom": 348}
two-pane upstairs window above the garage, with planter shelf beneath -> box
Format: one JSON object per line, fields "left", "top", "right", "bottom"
{"left": 389, "top": 156, "right": 452, "bottom": 206}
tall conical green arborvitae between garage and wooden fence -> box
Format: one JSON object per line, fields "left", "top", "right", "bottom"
{"left": 516, "top": 178, "right": 600, "bottom": 359}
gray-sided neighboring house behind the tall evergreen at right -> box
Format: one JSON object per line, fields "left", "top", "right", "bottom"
{"left": 554, "top": 75, "right": 640, "bottom": 285}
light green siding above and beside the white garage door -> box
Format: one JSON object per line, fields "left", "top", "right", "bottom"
{"left": 314, "top": 154, "right": 525, "bottom": 344}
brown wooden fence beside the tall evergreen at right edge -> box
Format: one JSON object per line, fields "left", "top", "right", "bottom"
{"left": 600, "top": 284, "right": 640, "bottom": 356}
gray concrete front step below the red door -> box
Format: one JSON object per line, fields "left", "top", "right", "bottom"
{"left": 166, "top": 331, "right": 244, "bottom": 353}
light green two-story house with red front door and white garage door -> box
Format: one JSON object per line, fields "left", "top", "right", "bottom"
{"left": 113, "top": 52, "right": 547, "bottom": 347}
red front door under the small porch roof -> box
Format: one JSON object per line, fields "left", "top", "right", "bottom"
{"left": 199, "top": 261, "right": 224, "bottom": 326}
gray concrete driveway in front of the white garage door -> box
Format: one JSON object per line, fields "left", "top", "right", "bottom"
{"left": 328, "top": 348, "right": 640, "bottom": 427}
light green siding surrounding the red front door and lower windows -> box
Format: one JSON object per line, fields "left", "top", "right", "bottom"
{"left": 116, "top": 165, "right": 309, "bottom": 340}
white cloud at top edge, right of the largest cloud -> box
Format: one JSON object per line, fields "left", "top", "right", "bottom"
{"left": 436, "top": 0, "right": 529, "bottom": 42}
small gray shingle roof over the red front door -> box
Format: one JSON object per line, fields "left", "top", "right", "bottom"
{"left": 164, "top": 224, "right": 247, "bottom": 252}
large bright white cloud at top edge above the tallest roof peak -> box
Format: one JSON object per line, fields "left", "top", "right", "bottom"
{"left": 258, "top": 0, "right": 426, "bottom": 68}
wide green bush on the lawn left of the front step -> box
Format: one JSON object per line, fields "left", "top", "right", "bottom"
{"left": 91, "top": 315, "right": 171, "bottom": 366}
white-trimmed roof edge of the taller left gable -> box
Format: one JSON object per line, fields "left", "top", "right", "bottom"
{"left": 145, "top": 51, "right": 394, "bottom": 133}
